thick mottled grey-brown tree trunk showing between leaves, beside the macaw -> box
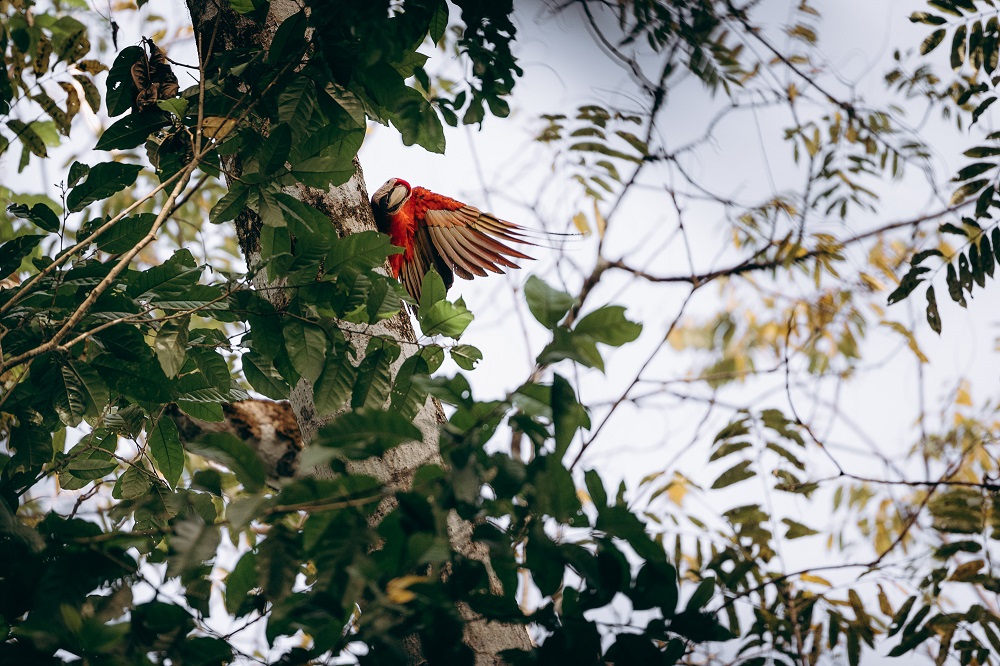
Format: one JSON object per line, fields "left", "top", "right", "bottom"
{"left": 187, "top": 0, "right": 531, "bottom": 666}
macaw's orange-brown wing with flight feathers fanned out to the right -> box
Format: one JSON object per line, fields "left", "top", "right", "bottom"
{"left": 420, "top": 206, "right": 534, "bottom": 280}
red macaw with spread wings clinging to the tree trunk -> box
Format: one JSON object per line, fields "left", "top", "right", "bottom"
{"left": 372, "top": 178, "right": 534, "bottom": 303}
